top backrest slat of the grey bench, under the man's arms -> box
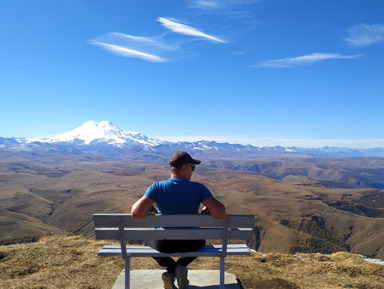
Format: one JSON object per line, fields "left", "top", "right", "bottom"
{"left": 93, "top": 214, "right": 254, "bottom": 228}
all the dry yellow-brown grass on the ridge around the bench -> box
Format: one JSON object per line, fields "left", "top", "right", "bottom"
{"left": 0, "top": 236, "right": 384, "bottom": 289}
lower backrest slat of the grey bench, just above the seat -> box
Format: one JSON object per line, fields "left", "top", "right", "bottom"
{"left": 95, "top": 228, "right": 253, "bottom": 240}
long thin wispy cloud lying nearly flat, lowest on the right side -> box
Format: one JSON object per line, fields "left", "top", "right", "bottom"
{"left": 255, "top": 53, "right": 361, "bottom": 68}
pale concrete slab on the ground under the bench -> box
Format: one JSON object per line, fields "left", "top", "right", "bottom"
{"left": 112, "top": 270, "right": 240, "bottom": 289}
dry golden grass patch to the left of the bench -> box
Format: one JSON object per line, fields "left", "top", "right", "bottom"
{"left": 0, "top": 236, "right": 123, "bottom": 289}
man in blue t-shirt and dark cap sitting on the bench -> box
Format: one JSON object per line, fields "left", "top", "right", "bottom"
{"left": 131, "top": 151, "right": 227, "bottom": 289}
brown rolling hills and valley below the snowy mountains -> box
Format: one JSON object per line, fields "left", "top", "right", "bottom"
{"left": 0, "top": 152, "right": 384, "bottom": 259}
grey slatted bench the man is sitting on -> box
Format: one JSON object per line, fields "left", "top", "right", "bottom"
{"left": 93, "top": 214, "right": 254, "bottom": 289}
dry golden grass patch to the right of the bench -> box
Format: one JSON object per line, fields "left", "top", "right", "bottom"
{"left": 222, "top": 253, "right": 384, "bottom": 289}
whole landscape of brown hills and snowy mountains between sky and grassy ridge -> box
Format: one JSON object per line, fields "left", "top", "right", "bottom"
{"left": 0, "top": 122, "right": 384, "bottom": 259}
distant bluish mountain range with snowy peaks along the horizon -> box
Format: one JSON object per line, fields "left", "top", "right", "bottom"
{"left": 0, "top": 121, "right": 384, "bottom": 160}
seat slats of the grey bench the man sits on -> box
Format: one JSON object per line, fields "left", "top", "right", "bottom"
{"left": 98, "top": 244, "right": 250, "bottom": 257}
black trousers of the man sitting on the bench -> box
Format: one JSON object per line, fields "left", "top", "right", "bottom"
{"left": 147, "top": 240, "right": 205, "bottom": 274}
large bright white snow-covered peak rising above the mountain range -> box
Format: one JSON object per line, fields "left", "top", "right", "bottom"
{"left": 41, "top": 120, "right": 161, "bottom": 146}
